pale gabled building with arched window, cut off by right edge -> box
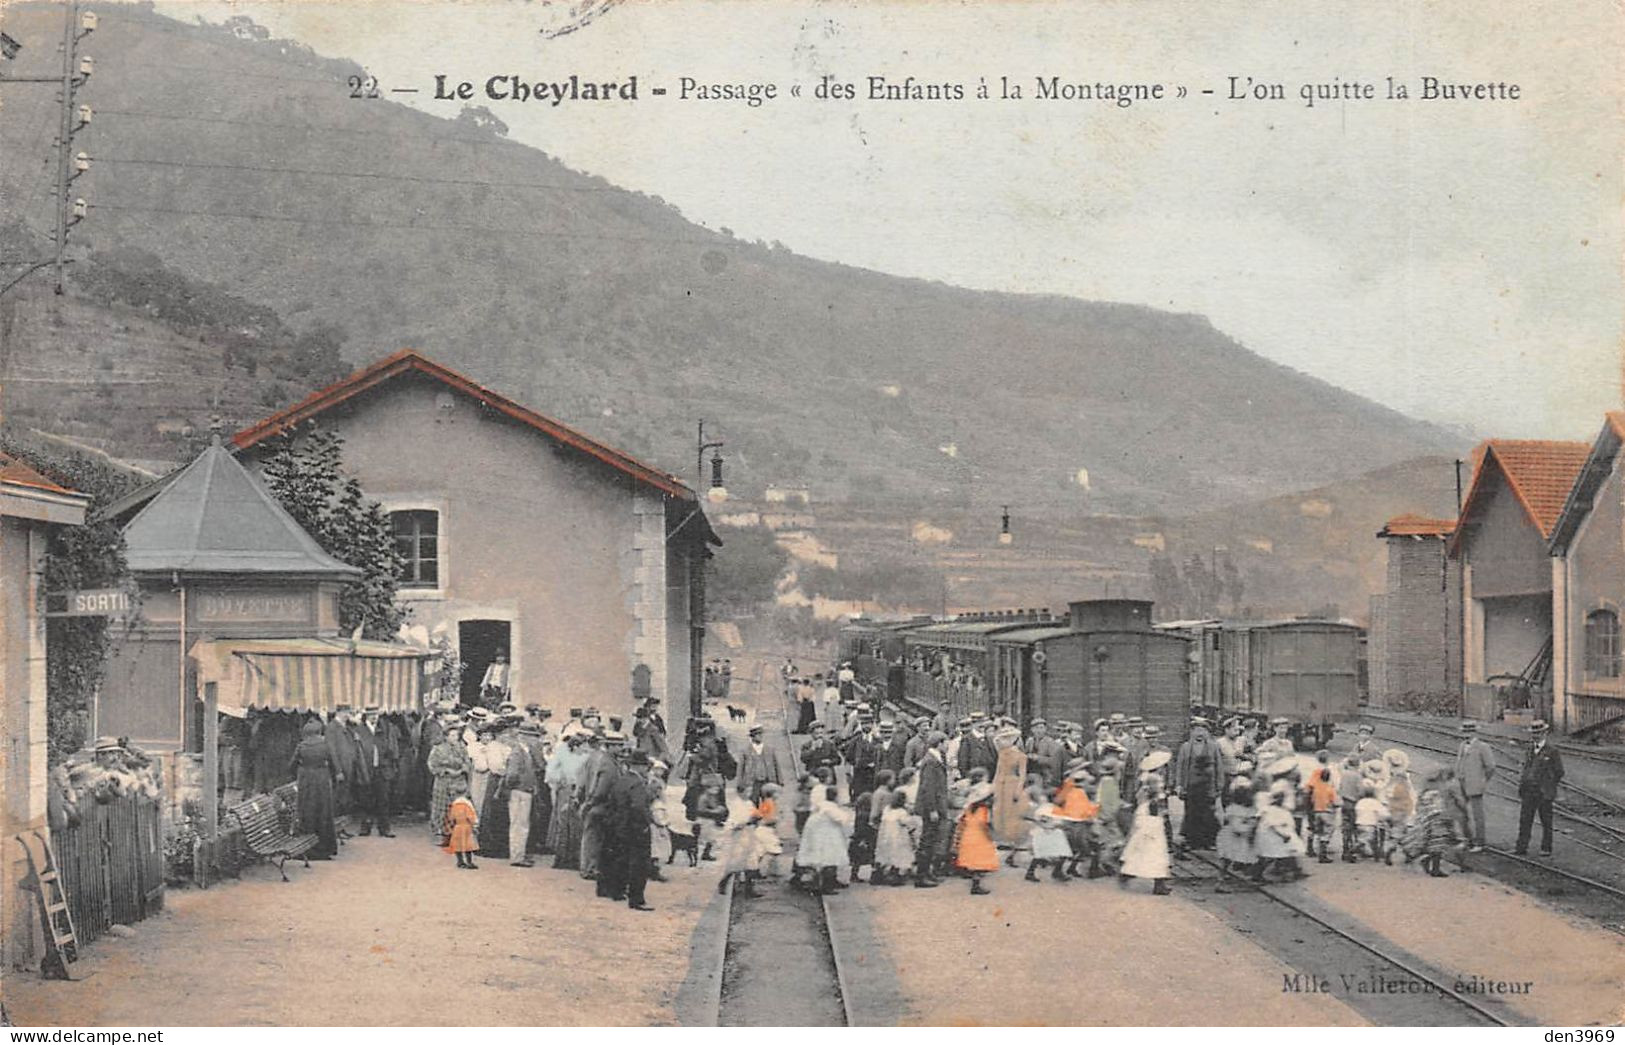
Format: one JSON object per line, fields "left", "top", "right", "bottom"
{"left": 1550, "top": 413, "right": 1625, "bottom": 733}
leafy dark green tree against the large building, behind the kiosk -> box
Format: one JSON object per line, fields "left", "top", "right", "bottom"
{"left": 265, "top": 423, "right": 406, "bottom": 640}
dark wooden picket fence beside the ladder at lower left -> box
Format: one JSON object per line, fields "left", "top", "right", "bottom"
{"left": 52, "top": 796, "right": 164, "bottom": 943}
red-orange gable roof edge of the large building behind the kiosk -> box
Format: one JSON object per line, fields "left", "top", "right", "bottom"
{"left": 231, "top": 349, "right": 696, "bottom": 501}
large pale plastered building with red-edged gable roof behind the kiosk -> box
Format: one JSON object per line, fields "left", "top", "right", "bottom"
{"left": 234, "top": 351, "right": 722, "bottom": 718}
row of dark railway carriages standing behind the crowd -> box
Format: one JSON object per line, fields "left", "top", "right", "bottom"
{"left": 837, "top": 598, "right": 1363, "bottom": 749}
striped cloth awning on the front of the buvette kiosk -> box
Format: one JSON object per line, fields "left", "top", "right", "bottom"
{"left": 192, "top": 639, "right": 431, "bottom": 713}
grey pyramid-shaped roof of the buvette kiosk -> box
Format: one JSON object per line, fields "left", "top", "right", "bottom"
{"left": 124, "top": 442, "right": 361, "bottom": 579}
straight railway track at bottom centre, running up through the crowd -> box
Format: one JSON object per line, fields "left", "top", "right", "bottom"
{"left": 713, "top": 663, "right": 856, "bottom": 1027}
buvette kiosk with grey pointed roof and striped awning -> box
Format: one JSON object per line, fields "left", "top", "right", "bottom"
{"left": 96, "top": 437, "right": 424, "bottom": 845}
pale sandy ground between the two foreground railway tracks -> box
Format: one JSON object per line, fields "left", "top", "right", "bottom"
{"left": 835, "top": 869, "right": 1365, "bottom": 1027}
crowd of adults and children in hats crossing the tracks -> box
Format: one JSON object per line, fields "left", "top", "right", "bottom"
{"left": 282, "top": 665, "right": 1562, "bottom": 910}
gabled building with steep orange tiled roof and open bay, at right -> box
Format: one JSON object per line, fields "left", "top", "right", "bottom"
{"left": 1450, "top": 439, "right": 1591, "bottom": 713}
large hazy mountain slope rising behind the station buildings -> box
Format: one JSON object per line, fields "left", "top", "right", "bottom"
{"left": 0, "top": 5, "right": 1459, "bottom": 518}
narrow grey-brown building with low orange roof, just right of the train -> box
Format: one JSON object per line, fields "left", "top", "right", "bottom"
{"left": 1368, "top": 515, "right": 1461, "bottom": 707}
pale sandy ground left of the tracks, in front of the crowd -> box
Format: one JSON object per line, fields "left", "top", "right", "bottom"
{"left": 7, "top": 821, "right": 717, "bottom": 1025}
